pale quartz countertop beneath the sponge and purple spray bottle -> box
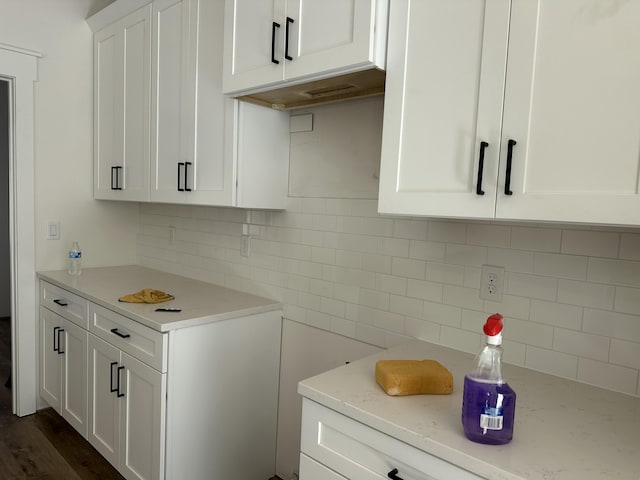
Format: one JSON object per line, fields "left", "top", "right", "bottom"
{"left": 298, "top": 340, "right": 640, "bottom": 480}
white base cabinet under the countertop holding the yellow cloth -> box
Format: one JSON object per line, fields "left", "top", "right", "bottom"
{"left": 40, "top": 272, "right": 282, "bottom": 480}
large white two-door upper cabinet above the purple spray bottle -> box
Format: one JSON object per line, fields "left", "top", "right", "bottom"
{"left": 379, "top": 0, "right": 640, "bottom": 224}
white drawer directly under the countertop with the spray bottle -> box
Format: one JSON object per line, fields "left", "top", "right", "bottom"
{"left": 300, "top": 398, "right": 480, "bottom": 480}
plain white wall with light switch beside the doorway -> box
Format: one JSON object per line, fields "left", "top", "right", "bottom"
{"left": 0, "top": 0, "right": 138, "bottom": 270}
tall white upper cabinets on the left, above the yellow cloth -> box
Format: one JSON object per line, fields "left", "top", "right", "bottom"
{"left": 88, "top": 0, "right": 289, "bottom": 209}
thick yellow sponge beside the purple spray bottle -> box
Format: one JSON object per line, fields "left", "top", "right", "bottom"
{"left": 376, "top": 360, "right": 453, "bottom": 396}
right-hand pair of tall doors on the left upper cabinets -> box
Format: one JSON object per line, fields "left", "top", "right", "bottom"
{"left": 151, "top": 0, "right": 237, "bottom": 205}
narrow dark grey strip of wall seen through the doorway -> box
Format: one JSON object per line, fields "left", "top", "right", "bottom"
{"left": 0, "top": 80, "right": 11, "bottom": 318}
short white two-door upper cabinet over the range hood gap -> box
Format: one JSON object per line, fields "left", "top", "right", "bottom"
{"left": 224, "top": 0, "right": 389, "bottom": 93}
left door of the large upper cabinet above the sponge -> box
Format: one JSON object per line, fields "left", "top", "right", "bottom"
{"left": 378, "top": 0, "right": 510, "bottom": 218}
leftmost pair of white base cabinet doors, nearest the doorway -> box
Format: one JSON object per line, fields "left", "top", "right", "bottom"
{"left": 40, "top": 307, "right": 87, "bottom": 438}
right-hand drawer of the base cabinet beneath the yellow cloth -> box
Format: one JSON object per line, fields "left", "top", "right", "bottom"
{"left": 89, "top": 303, "right": 167, "bottom": 373}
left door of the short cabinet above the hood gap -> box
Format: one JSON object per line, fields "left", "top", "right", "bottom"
{"left": 223, "top": 0, "right": 286, "bottom": 93}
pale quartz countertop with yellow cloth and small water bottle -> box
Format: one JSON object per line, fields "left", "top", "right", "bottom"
{"left": 38, "top": 265, "right": 282, "bottom": 332}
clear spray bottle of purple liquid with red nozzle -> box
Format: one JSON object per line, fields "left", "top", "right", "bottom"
{"left": 462, "top": 313, "right": 516, "bottom": 445}
